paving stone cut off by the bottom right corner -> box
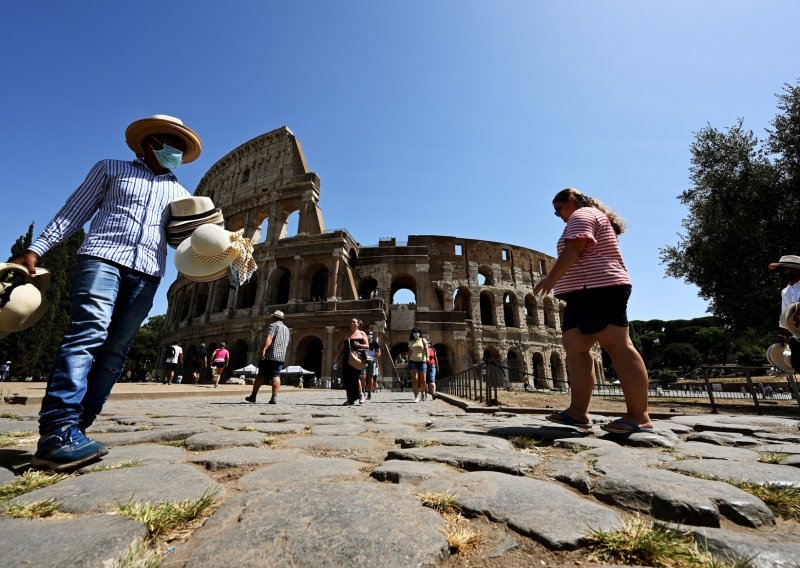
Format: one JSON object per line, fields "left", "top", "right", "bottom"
{"left": 671, "top": 525, "right": 800, "bottom": 568}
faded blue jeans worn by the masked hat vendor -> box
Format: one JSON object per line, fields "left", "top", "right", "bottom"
{"left": 39, "top": 255, "right": 161, "bottom": 436}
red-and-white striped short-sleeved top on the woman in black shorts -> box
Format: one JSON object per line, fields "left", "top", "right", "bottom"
{"left": 553, "top": 207, "right": 631, "bottom": 294}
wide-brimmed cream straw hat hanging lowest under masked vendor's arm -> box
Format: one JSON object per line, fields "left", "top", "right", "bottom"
{"left": 175, "top": 225, "right": 239, "bottom": 282}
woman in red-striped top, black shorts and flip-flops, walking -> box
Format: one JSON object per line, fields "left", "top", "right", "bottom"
{"left": 533, "top": 188, "right": 653, "bottom": 434}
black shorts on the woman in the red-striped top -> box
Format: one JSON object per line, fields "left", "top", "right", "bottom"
{"left": 556, "top": 286, "right": 631, "bottom": 335}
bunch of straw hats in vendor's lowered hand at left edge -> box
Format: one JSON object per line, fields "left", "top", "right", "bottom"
{"left": 0, "top": 263, "right": 50, "bottom": 339}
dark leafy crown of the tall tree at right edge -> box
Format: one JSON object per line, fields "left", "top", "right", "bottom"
{"left": 661, "top": 82, "right": 800, "bottom": 332}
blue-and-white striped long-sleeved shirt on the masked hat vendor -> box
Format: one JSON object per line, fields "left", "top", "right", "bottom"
{"left": 29, "top": 158, "right": 190, "bottom": 277}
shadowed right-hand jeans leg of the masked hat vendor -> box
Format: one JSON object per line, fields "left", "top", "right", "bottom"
{"left": 80, "top": 269, "right": 159, "bottom": 431}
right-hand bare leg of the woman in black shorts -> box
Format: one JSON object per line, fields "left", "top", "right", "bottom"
{"left": 593, "top": 325, "right": 652, "bottom": 426}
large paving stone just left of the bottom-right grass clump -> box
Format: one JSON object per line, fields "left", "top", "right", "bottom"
{"left": 419, "top": 471, "right": 623, "bottom": 549}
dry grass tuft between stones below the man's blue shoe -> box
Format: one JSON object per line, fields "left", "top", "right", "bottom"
{"left": 116, "top": 489, "right": 219, "bottom": 542}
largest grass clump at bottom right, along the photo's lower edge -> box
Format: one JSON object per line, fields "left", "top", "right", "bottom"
{"left": 589, "top": 516, "right": 752, "bottom": 568}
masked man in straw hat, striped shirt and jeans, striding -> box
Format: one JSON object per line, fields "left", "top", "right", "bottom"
{"left": 11, "top": 115, "right": 202, "bottom": 471}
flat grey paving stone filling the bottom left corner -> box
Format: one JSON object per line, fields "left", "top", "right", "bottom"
{"left": 0, "top": 515, "right": 147, "bottom": 568}
